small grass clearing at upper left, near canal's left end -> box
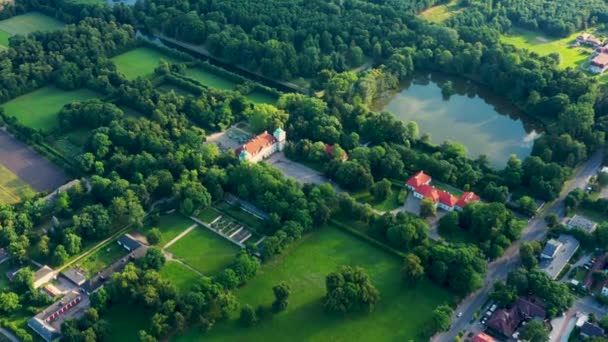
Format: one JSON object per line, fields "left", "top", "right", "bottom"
{"left": 112, "top": 47, "right": 180, "bottom": 79}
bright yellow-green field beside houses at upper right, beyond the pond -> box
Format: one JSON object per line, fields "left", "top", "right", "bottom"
{"left": 501, "top": 28, "right": 593, "bottom": 68}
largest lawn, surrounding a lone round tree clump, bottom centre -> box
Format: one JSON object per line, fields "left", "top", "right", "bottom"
{"left": 175, "top": 226, "right": 454, "bottom": 342}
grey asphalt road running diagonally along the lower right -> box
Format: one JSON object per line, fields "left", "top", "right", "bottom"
{"left": 432, "top": 152, "right": 602, "bottom": 342}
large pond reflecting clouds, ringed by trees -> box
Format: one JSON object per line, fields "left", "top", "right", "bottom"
{"left": 373, "top": 73, "right": 542, "bottom": 168}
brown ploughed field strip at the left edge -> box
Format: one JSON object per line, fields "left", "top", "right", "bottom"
{"left": 0, "top": 130, "right": 68, "bottom": 191}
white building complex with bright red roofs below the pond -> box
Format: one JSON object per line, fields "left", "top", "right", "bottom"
{"left": 405, "top": 171, "right": 480, "bottom": 211}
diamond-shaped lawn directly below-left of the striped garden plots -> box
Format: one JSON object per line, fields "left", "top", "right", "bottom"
{"left": 169, "top": 226, "right": 239, "bottom": 275}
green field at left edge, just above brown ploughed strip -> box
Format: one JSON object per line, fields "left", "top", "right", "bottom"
{"left": 2, "top": 86, "right": 99, "bottom": 131}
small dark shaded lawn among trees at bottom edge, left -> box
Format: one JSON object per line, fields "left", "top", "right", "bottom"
{"left": 103, "top": 302, "right": 152, "bottom": 342}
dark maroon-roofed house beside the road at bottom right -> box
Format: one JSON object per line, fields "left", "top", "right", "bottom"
{"left": 487, "top": 298, "right": 547, "bottom": 338}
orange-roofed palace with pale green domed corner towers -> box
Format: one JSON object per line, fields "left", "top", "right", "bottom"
{"left": 234, "top": 128, "right": 287, "bottom": 163}
